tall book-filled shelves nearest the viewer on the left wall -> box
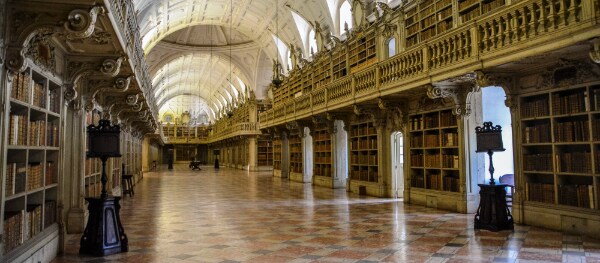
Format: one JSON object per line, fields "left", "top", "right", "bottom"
{"left": 0, "top": 68, "right": 62, "bottom": 261}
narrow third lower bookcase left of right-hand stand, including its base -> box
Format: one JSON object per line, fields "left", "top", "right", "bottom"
{"left": 312, "top": 127, "right": 334, "bottom": 188}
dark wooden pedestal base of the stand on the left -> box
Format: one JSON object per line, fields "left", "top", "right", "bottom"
{"left": 79, "top": 197, "right": 128, "bottom": 256}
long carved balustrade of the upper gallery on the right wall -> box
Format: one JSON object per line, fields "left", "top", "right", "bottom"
{"left": 259, "top": 0, "right": 600, "bottom": 128}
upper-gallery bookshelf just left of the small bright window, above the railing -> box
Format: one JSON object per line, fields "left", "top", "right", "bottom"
{"left": 348, "top": 30, "right": 377, "bottom": 73}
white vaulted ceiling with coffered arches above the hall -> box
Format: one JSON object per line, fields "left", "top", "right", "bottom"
{"left": 134, "top": 0, "right": 346, "bottom": 124}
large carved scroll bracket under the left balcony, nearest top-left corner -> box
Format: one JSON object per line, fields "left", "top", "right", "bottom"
{"left": 63, "top": 5, "right": 104, "bottom": 40}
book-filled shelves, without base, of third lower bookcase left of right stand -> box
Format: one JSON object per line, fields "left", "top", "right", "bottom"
{"left": 313, "top": 128, "right": 333, "bottom": 177}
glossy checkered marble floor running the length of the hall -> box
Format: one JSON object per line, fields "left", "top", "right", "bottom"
{"left": 53, "top": 166, "right": 600, "bottom": 263}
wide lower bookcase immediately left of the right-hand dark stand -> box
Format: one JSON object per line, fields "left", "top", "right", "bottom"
{"left": 409, "top": 109, "right": 460, "bottom": 192}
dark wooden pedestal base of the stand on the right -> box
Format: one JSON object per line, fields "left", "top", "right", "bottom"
{"left": 475, "top": 184, "right": 514, "bottom": 231}
